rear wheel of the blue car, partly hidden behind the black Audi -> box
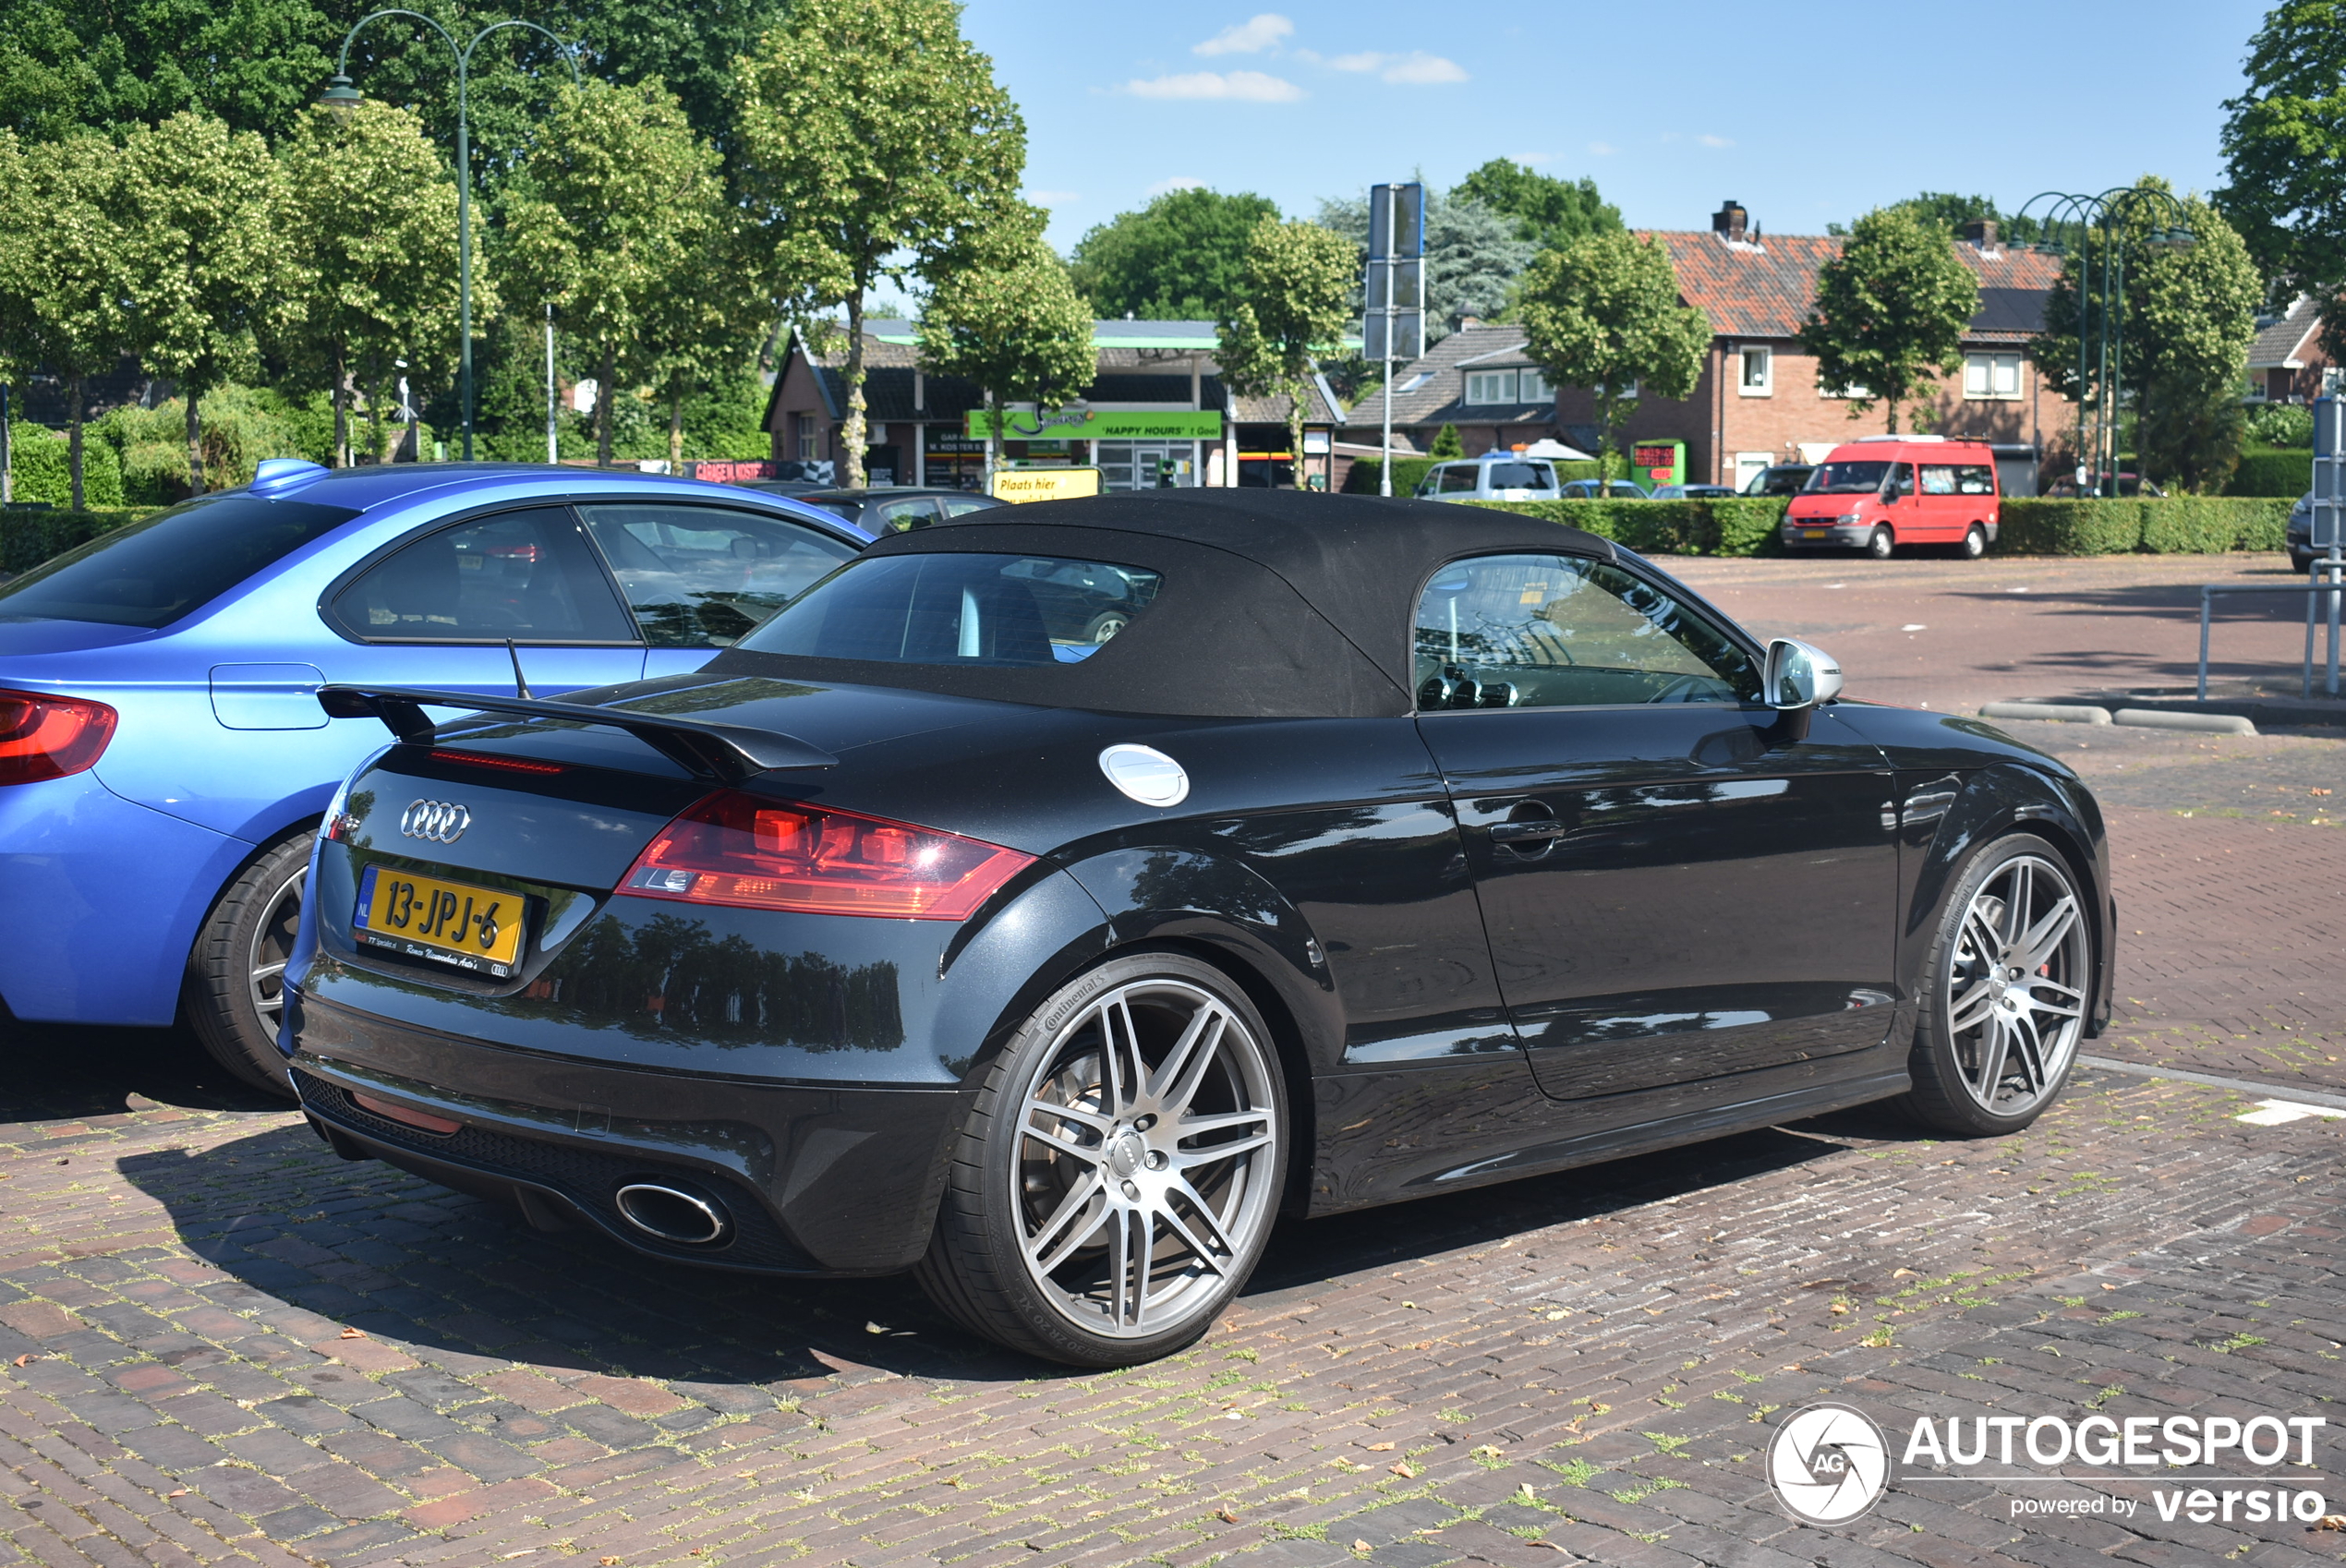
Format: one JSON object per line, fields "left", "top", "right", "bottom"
{"left": 181, "top": 832, "right": 314, "bottom": 1099}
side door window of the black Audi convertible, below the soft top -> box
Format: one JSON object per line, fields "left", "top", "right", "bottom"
{"left": 1415, "top": 556, "right": 1760, "bottom": 713}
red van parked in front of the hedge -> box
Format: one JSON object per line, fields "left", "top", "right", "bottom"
{"left": 1783, "top": 436, "right": 2001, "bottom": 561}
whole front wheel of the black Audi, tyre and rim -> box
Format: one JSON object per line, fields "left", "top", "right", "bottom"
{"left": 1905, "top": 832, "right": 2095, "bottom": 1137}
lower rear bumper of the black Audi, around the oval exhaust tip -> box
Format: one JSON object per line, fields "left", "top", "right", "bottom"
{"left": 291, "top": 996, "right": 972, "bottom": 1275}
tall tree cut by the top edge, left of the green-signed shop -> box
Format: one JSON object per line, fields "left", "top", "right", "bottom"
{"left": 739, "top": 0, "right": 1025, "bottom": 485}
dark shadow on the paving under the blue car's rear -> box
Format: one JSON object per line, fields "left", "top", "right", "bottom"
{"left": 0, "top": 1018, "right": 286, "bottom": 1123}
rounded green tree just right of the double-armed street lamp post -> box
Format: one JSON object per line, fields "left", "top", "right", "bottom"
{"left": 504, "top": 79, "right": 716, "bottom": 462}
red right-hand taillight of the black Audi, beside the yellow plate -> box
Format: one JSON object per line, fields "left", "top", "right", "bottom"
{"left": 620, "top": 790, "right": 1034, "bottom": 921}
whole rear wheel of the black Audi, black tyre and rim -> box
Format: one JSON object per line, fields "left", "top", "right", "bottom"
{"left": 913, "top": 951, "right": 1288, "bottom": 1367}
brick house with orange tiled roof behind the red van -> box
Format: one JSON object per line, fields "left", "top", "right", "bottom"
{"left": 1555, "top": 201, "right": 2072, "bottom": 495}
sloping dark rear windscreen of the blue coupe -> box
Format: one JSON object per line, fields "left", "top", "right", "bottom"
{"left": 0, "top": 492, "right": 359, "bottom": 631}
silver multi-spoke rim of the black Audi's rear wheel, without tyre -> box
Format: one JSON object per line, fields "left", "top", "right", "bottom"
{"left": 1009, "top": 977, "right": 1278, "bottom": 1338}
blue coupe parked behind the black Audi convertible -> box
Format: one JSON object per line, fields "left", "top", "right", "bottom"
{"left": 0, "top": 459, "right": 870, "bottom": 1094}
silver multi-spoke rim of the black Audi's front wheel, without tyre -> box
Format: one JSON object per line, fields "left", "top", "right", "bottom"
{"left": 1945, "top": 855, "right": 2088, "bottom": 1116}
